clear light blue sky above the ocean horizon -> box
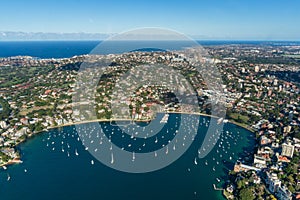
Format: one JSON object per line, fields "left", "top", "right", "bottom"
{"left": 0, "top": 0, "right": 300, "bottom": 40}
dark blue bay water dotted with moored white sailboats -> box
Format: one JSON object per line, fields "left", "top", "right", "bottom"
{"left": 0, "top": 114, "right": 253, "bottom": 200}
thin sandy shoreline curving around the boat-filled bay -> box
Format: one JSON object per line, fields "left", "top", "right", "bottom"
{"left": 0, "top": 112, "right": 255, "bottom": 167}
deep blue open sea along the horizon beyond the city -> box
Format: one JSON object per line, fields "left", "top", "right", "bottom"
{"left": 0, "top": 41, "right": 300, "bottom": 58}
